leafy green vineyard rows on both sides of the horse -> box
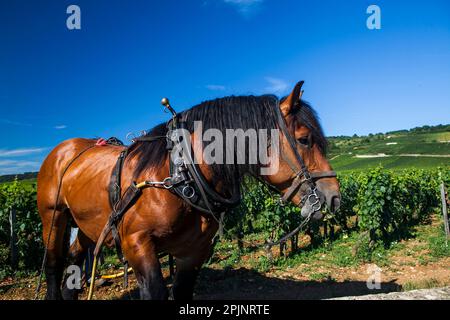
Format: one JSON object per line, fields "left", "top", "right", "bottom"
{"left": 0, "top": 167, "right": 450, "bottom": 298}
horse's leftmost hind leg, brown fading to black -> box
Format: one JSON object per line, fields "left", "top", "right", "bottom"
{"left": 41, "top": 209, "right": 68, "bottom": 300}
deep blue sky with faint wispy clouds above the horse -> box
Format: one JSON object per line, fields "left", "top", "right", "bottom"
{"left": 0, "top": 0, "right": 450, "bottom": 174}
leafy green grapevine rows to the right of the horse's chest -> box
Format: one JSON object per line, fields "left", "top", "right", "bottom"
{"left": 225, "top": 167, "right": 450, "bottom": 261}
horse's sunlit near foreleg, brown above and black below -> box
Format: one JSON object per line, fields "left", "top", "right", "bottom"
{"left": 123, "top": 236, "right": 168, "bottom": 300}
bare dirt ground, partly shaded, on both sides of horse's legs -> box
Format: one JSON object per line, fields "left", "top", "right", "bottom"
{"left": 0, "top": 258, "right": 450, "bottom": 300}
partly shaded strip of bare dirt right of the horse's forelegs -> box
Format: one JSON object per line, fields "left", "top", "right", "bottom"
{"left": 195, "top": 258, "right": 450, "bottom": 299}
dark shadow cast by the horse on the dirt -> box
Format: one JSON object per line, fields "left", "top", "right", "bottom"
{"left": 117, "top": 268, "right": 401, "bottom": 300}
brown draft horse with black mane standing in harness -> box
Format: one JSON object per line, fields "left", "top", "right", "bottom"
{"left": 38, "top": 82, "right": 340, "bottom": 299}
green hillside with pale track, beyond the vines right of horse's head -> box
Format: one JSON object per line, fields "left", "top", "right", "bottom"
{"left": 328, "top": 125, "right": 450, "bottom": 171}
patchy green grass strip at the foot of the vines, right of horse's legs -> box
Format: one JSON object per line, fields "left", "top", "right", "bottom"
{"left": 211, "top": 215, "right": 450, "bottom": 287}
